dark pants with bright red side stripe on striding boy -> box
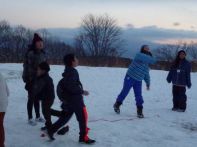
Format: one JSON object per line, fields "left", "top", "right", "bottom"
{"left": 52, "top": 104, "right": 88, "bottom": 140}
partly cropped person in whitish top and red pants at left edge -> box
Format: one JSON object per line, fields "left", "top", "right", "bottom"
{"left": 0, "top": 73, "right": 9, "bottom": 147}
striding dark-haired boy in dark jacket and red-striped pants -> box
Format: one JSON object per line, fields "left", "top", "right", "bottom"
{"left": 49, "top": 54, "right": 95, "bottom": 144}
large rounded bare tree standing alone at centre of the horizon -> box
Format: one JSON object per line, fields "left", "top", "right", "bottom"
{"left": 75, "top": 14, "right": 123, "bottom": 56}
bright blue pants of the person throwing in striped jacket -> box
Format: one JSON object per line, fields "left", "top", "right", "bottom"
{"left": 117, "top": 75, "right": 144, "bottom": 107}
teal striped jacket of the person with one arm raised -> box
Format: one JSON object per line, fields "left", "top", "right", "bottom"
{"left": 127, "top": 53, "right": 156, "bottom": 86}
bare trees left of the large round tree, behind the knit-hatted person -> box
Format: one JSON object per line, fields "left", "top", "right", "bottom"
{"left": 0, "top": 21, "right": 73, "bottom": 62}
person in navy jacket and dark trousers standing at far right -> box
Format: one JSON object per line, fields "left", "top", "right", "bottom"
{"left": 167, "top": 50, "right": 192, "bottom": 112}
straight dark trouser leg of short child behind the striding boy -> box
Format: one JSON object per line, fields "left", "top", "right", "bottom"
{"left": 42, "top": 100, "right": 54, "bottom": 130}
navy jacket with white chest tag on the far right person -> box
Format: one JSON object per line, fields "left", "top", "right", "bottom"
{"left": 167, "top": 59, "right": 192, "bottom": 88}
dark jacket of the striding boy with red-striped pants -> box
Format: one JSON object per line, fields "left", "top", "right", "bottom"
{"left": 62, "top": 67, "right": 84, "bottom": 103}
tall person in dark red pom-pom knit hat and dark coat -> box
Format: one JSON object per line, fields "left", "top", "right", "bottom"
{"left": 22, "top": 33, "right": 47, "bottom": 126}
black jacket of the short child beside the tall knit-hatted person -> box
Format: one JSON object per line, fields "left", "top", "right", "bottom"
{"left": 32, "top": 73, "right": 55, "bottom": 100}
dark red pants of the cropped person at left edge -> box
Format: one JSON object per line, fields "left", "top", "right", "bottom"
{"left": 0, "top": 112, "right": 5, "bottom": 147}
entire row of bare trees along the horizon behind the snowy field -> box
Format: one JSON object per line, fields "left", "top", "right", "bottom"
{"left": 0, "top": 14, "right": 197, "bottom": 63}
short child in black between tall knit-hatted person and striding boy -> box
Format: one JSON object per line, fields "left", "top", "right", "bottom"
{"left": 32, "top": 62, "right": 55, "bottom": 138}
